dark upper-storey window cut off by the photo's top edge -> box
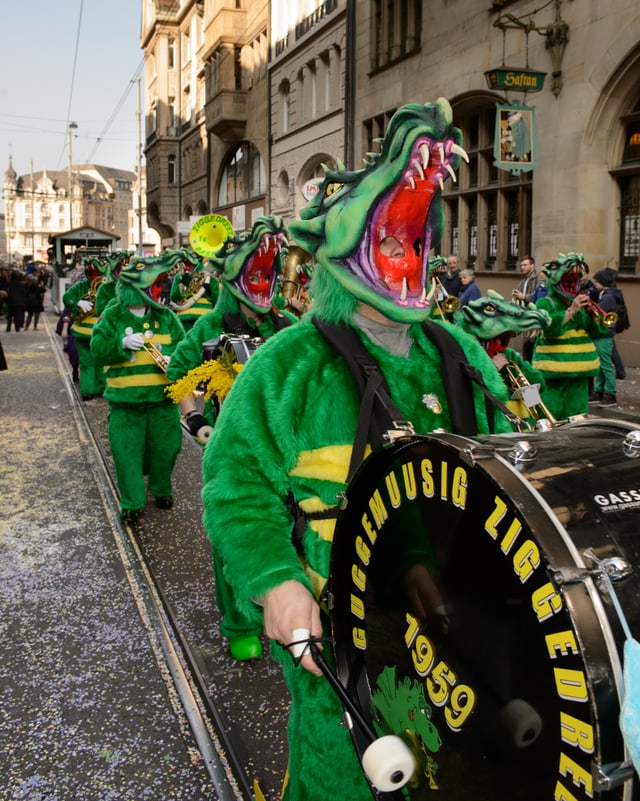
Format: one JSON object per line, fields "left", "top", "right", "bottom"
{"left": 372, "top": 0, "right": 422, "bottom": 70}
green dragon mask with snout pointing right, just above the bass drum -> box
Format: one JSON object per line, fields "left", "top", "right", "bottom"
{"left": 456, "top": 289, "right": 551, "bottom": 356}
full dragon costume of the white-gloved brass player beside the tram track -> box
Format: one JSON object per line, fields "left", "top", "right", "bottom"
{"left": 91, "top": 258, "right": 184, "bottom": 519}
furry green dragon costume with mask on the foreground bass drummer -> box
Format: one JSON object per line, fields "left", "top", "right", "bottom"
{"left": 202, "top": 100, "right": 509, "bottom": 801}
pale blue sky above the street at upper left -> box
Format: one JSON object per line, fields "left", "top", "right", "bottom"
{"left": 0, "top": 0, "right": 144, "bottom": 179}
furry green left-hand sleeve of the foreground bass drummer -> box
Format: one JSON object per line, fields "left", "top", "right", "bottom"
{"left": 202, "top": 337, "right": 311, "bottom": 620}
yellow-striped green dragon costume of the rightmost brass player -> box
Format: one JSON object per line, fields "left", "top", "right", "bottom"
{"left": 532, "top": 253, "right": 607, "bottom": 420}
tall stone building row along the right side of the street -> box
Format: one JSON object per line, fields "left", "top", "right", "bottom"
{"left": 143, "top": 0, "right": 640, "bottom": 363}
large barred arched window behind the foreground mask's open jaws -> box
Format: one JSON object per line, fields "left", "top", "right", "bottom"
{"left": 439, "top": 103, "right": 532, "bottom": 271}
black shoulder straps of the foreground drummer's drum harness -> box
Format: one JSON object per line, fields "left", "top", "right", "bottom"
{"left": 287, "top": 317, "right": 522, "bottom": 553}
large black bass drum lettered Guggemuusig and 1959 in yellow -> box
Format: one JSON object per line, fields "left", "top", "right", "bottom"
{"left": 327, "top": 418, "right": 640, "bottom": 801}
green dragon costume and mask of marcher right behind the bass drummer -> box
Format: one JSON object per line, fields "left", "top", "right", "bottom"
{"left": 167, "top": 217, "right": 297, "bottom": 650}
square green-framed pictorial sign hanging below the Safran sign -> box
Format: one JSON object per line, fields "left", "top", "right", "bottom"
{"left": 493, "top": 101, "right": 538, "bottom": 174}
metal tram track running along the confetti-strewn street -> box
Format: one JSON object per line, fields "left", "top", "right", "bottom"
{"left": 46, "top": 314, "right": 254, "bottom": 801}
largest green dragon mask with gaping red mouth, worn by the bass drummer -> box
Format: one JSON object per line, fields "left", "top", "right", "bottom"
{"left": 289, "top": 98, "right": 467, "bottom": 323}
